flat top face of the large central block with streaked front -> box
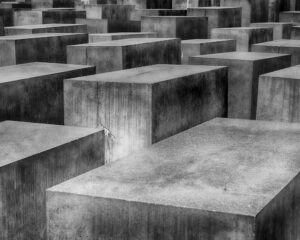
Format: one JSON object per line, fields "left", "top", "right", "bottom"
{"left": 67, "top": 64, "right": 224, "bottom": 84}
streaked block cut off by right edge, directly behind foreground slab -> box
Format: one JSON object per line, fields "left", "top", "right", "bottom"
{"left": 256, "top": 65, "right": 300, "bottom": 122}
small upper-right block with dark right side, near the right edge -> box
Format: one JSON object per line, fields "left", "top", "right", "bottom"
{"left": 251, "top": 22, "right": 293, "bottom": 40}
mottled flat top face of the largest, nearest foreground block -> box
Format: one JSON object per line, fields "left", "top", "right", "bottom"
{"left": 49, "top": 119, "right": 300, "bottom": 216}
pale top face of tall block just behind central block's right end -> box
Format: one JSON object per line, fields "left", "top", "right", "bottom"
{"left": 192, "top": 52, "right": 287, "bottom": 61}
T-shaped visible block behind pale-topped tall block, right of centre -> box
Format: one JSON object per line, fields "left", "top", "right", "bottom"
{"left": 211, "top": 27, "right": 273, "bottom": 52}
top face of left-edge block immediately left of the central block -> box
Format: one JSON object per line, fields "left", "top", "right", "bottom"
{"left": 0, "top": 62, "right": 91, "bottom": 84}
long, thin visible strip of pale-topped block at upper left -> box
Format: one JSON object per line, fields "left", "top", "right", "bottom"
{"left": 5, "top": 23, "right": 87, "bottom": 35}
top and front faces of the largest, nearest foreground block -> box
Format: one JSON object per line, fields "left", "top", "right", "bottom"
{"left": 47, "top": 119, "right": 300, "bottom": 240}
